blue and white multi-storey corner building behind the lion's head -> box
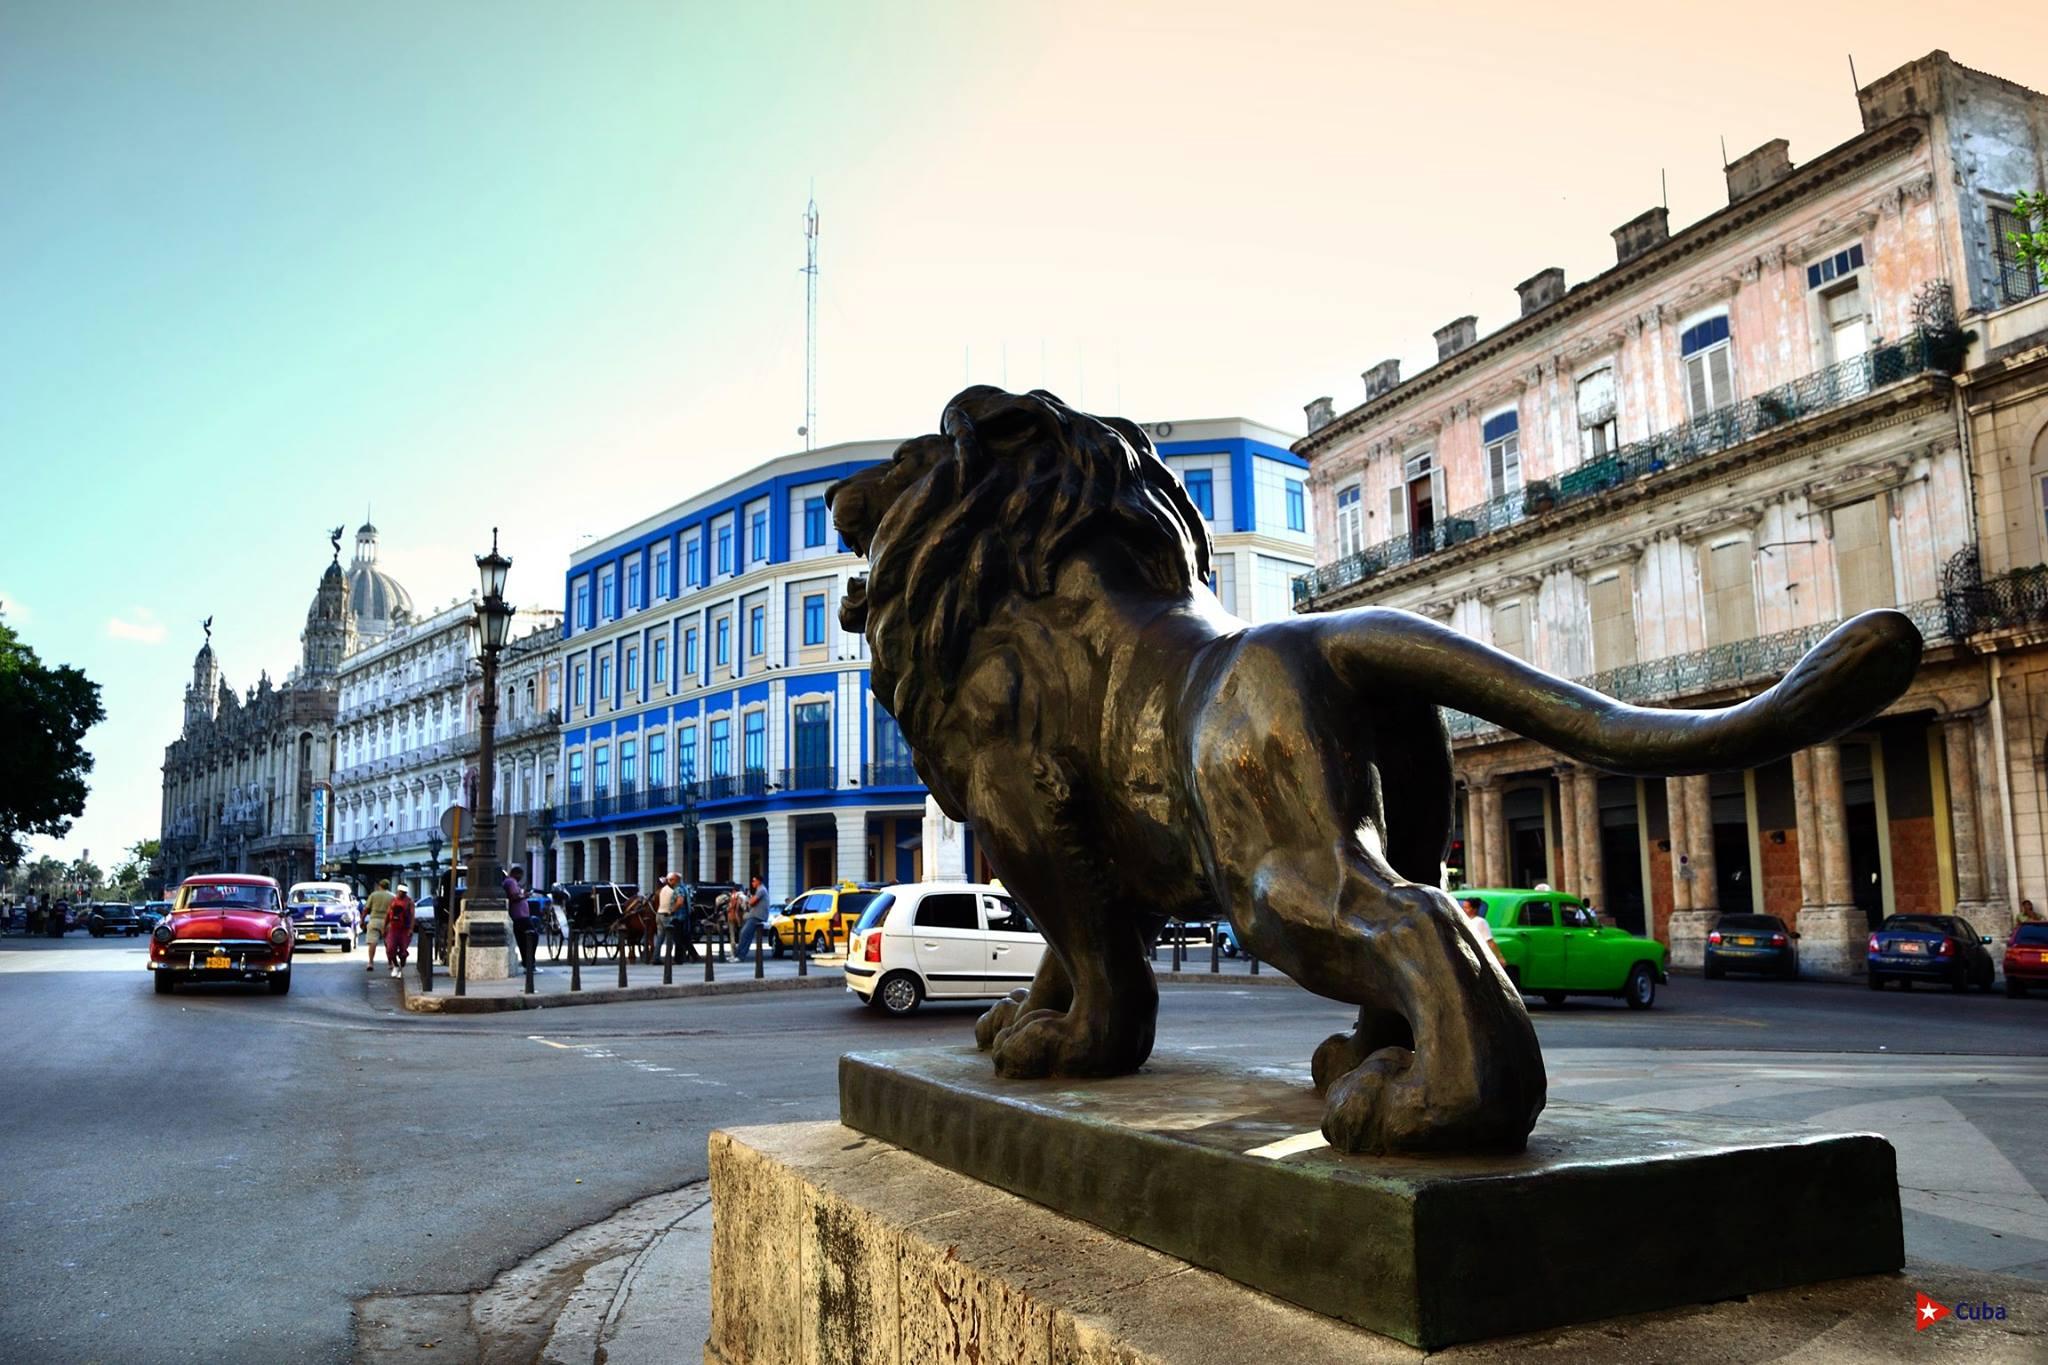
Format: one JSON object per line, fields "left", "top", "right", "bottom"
{"left": 555, "top": 420, "right": 1315, "bottom": 898}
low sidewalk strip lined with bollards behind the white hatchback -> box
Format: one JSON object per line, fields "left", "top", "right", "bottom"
{"left": 387, "top": 945, "right": 1294, "bottom": 1015}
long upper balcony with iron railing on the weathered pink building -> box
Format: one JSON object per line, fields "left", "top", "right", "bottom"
{"left": 1294, "top": 332, "right": 1954, "bottom": 612}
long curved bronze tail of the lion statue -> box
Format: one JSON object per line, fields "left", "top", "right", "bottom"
{"left": 1303, "top": 608, "right": 1921, "bottom": 778}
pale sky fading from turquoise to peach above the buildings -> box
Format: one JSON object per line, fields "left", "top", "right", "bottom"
{"left": 0, "top": 0, "right": 2048, "bottom": 868}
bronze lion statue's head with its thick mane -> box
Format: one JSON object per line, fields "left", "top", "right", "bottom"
{"left": 827, "top": 385, "right": 1210, "bottom": 743}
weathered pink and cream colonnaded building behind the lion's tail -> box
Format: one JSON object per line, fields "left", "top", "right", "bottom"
{"left": 1294, "top": 53, "right": 2048, "bottom": 974}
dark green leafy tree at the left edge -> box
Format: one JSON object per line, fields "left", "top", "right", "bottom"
{"left": 0, "top": 620, "right": 106, "bottom": 866}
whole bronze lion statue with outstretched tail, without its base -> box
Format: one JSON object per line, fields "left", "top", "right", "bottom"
{"left": 831, "top": 387, "right": 1921, "bottom": 1152}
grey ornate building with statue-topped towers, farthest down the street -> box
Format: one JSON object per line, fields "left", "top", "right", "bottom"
{"left": 162, "top": 526, "right": 360, "bottom": 886}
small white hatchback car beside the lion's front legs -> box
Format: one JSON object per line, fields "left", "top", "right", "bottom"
{"left": 846, "top": 882, "right": 1044, "bottom": 1015}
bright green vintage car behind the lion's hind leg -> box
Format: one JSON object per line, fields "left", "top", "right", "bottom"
{"left": 1452, "top": 890, "right": 1665, "bottom": 1009}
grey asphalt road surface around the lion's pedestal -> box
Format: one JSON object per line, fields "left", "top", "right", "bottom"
{"left": 0, "top": 937, "right": 2048, "bottom": 1361}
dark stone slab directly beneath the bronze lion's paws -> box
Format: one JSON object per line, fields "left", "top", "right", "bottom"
{"left": 840, "top": 1048, "right": 1905, "bottom": 1349}
